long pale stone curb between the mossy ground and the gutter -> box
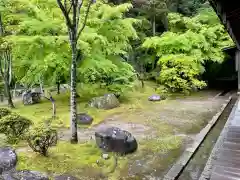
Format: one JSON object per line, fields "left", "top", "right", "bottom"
{"left": 163, "top": 96, "right": 232, "bottom": 180}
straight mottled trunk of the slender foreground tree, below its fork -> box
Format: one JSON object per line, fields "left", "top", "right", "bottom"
{"left": 70, "top": 35, "right": 78, "bottom": 143}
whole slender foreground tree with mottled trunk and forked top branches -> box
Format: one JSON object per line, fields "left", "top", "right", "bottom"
{"left": 57, "top": 0, "right": 95, "bottom": 143}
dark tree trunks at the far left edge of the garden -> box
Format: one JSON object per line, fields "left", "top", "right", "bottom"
{"left": 0, "top": 12, "right": 14, "bottom": 108}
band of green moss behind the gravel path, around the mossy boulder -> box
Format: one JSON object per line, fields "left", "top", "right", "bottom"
{"left": 8, "top": 83, "right": 163, "bottom": 128}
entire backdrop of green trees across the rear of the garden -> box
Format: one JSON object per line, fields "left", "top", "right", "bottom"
{"left": 0, "top": 0, "right": 233, "bottom": 136}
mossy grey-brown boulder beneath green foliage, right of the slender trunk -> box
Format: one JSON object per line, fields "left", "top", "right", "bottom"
{"left": 89, "top": 94, "right": 120, "bottom": 109}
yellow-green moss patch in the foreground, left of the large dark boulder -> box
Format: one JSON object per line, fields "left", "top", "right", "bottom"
{"left": 17, "top": 142, "right": 126, "bottom": 177}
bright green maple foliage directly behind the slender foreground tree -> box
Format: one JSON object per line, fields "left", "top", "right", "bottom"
{"left": 3, "top": 0, "right": 140, "bottom": 94}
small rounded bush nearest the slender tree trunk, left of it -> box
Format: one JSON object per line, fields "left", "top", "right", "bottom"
{"left": 27, "top": 124, "right": 58, "bottom": 156}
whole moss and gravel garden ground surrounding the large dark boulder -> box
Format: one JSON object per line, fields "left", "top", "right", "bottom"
{"left": 0, "top": 84, "right": 227, "bottom": 180}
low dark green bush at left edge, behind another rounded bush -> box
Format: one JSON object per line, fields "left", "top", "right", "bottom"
{"left": 0, "top": 113, "right": 32, "bottom": 144}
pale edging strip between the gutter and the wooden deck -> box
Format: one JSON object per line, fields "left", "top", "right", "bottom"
{"left": 199, "top": 95, "right": 240, "bottom": 180}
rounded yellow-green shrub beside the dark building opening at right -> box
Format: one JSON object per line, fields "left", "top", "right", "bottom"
{"left": 159, "top": 55, "right": 206, "bottom": 93}
